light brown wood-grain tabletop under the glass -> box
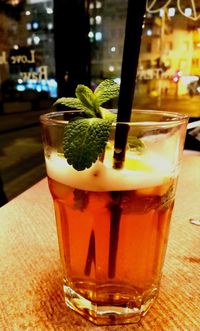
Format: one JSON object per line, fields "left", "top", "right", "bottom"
{"left": 0, "top": 154, "right": 200, "bottom": 331}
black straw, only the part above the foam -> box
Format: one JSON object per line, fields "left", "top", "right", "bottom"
{"left": 114, "top": 0, "right": 146, "bottom": 168}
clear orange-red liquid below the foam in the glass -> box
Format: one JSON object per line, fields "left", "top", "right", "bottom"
{"left": 49, "top": 178, "right": 174, "bottom": 307}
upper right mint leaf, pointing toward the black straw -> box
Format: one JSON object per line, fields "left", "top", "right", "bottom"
{"left": 94, "top": 79, "right": 119, "bottom": 106}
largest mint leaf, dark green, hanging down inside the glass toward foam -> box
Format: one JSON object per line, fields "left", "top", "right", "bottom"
{"left": 63, "top": 118, "right": 112, "bottom": 171}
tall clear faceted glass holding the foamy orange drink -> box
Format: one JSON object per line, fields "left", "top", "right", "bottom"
{"left": 41, "top": 110, "right": 187, "bottom": 325}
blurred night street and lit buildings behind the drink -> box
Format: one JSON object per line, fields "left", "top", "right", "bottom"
{"left": 0, "top": 0, "right": 200, "bottom": 205}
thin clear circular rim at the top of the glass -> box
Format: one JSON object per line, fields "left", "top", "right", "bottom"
{"left": 40, "top": 109, "right": 189, "bottom": 127}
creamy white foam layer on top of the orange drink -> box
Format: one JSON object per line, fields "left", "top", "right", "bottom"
{"left": 46, "top": 153, "right": 170, "bottom": 192}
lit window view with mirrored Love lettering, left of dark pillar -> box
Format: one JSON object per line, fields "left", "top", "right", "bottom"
{"left": 0, "top": 0, "right": 54, "bottom": 113}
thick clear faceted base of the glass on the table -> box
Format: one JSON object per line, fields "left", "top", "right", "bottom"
{"left": 64, "top": 284, "right": 158, "bottom": 325}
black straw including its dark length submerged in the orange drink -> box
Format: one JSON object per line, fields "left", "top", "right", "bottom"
{"left": 108, "top": 0, "right": 146, "bottom": 278}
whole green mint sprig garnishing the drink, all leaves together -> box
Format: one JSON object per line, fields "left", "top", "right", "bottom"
{"left": 54, "top": 79, "right": 119, "bottom": 171}
